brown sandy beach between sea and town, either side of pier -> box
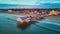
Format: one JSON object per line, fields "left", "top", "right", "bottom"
{"left": 0, "top": 13, "right": 60, "bottom": 20}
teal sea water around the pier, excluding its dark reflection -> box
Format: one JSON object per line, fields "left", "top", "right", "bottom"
{"left": 0, "top": 13, "right": 60, "bottom": 34}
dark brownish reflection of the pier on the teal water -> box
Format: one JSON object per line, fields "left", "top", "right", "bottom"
{"left": 17, "top": 21, "right": 38, "bottom": 32}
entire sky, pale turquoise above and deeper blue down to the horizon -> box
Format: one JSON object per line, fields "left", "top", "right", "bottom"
{"left": 0, "top": 0, "right": 60, "bottom": 9}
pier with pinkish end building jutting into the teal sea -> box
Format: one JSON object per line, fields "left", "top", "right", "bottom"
{"left": 16, "top": 16, "right": 43, "bottom": 24}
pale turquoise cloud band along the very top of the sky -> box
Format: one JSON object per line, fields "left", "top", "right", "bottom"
{"left": 0, "top": 0, "right": 60, "bottom": 5}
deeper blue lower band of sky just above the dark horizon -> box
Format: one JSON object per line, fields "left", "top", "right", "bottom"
{"left": 0, "top": 3, "right": 60, "bottom": 9}
